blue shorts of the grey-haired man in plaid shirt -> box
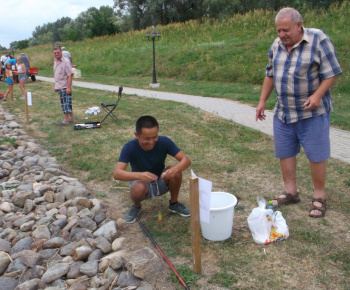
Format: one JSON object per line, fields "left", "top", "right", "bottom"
{"left": 273, "top": 113, "right": 331, "bottom": 162}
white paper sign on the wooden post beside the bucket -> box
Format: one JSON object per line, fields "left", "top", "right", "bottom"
{"left": 191, "top": 169, "right": 213, "bottom": 223}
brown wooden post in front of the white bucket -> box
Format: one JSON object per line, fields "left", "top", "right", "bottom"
{"left": 190, "top": 177, "right": 202, "bottom": 273}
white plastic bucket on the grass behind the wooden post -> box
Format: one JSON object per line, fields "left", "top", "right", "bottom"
{"left": 200, "top": 192, "right": 237, "bottom": 241}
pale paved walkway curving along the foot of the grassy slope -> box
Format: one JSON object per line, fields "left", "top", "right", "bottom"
{"left": 36, "top": 76, "right": 350, "bottom": 163}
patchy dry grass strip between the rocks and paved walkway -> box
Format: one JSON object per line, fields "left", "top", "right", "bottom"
{"left": 0, "top": 82, "right": 350, "bottom": 289}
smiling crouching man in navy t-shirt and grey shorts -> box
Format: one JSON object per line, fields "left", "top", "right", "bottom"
{"left": 113, "top": 116, "right": 191, "bottom": 223}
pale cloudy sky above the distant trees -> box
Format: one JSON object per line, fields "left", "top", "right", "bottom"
{"left": 0, "top": 0, "right": 114, "bottom": 48}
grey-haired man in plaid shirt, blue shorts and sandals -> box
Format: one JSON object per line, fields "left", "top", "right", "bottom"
{"left": 255, "top": 7, "right": 342, "bottom": 217}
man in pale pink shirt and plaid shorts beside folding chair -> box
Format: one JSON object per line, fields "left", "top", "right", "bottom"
{"left": 53, "top": 47, "right": 76, "bottom": 126}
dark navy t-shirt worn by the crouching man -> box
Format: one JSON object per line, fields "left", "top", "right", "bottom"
{"left": 118, "top": 136, "right": 180, "bottom": 177}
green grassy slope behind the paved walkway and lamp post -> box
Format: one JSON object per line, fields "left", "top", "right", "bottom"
{"left": 21, "top": 1, "right": 350, "bottom": 130}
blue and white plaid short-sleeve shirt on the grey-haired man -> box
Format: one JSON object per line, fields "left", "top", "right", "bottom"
{"left": 266, "top": 27, "right": 342, "bottom": 124}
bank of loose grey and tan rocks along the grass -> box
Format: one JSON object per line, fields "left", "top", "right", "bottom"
{"left": 0, "top": 106, "right": 163, "bottom": 290}
